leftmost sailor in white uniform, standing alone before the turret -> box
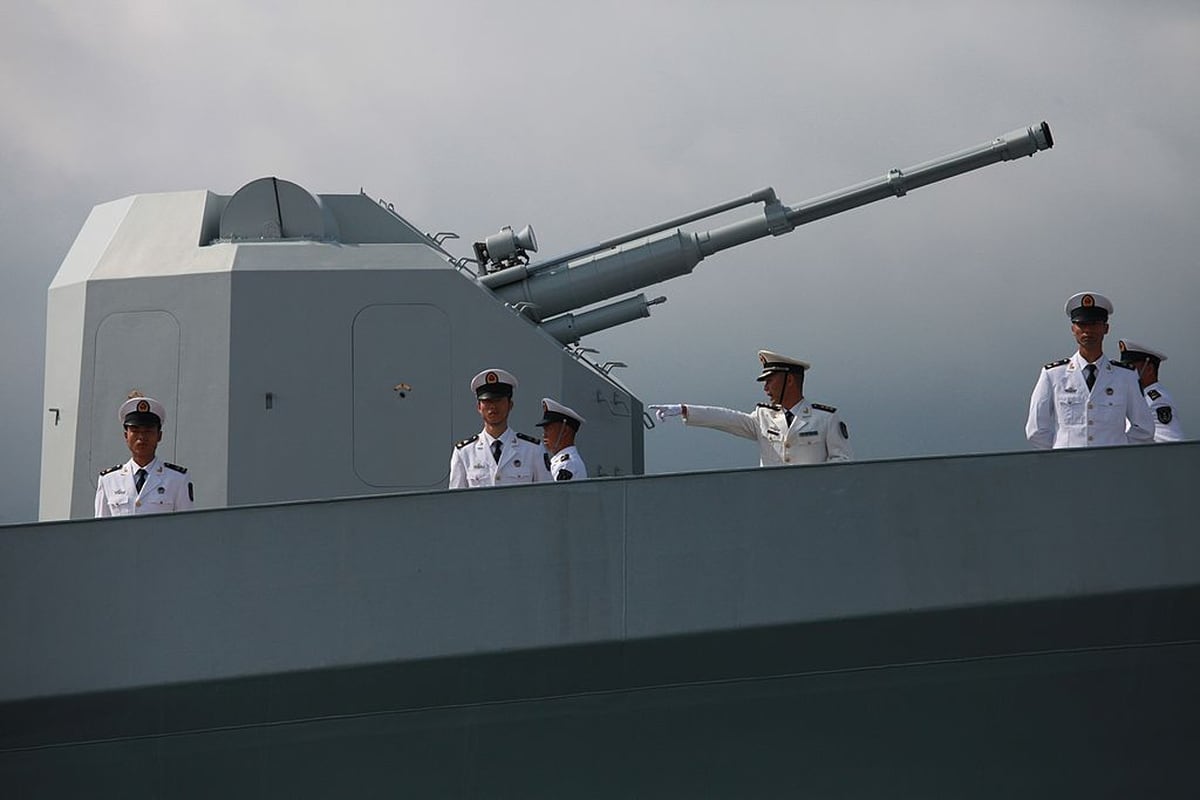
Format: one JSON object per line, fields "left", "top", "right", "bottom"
{"left": 95, "top": 393, "right": 194, "bottom": 517}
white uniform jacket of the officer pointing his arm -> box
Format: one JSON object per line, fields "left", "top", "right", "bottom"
{"left": 684, "top": 399, "right": 854, "bottom": 467}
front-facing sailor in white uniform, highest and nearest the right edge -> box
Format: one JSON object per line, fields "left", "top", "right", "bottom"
{"left": 1025, "top": 291, "right": 1154, "bottom": 450}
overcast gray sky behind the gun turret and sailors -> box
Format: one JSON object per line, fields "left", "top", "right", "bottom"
{"left": 0, "top": 0, "right": 1200, "bottom": 523}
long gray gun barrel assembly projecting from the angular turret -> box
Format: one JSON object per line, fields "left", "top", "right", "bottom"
{"left": 476, "top": 122, "right": 1054, "bottom": 343}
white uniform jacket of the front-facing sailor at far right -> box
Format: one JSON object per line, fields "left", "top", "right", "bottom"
{"left": 1025, "top": 351, "right": 1154, "bottom": 450}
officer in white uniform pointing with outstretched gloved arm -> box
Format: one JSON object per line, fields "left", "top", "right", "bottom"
{"left": 649, "top": 350, "right": 854, "bottom": 467}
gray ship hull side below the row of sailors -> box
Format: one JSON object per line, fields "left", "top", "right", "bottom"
{"left": 0, "top": 443, "right": 1200, "bottom": 798}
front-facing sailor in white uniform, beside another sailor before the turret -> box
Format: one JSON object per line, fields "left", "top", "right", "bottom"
{"left": 450, "top": 369, "right": 550, "bottom": 489}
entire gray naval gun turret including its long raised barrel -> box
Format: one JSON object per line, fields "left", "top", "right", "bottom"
{"left": 40, "top": 122, "right": 1052, "bottom": 525}
